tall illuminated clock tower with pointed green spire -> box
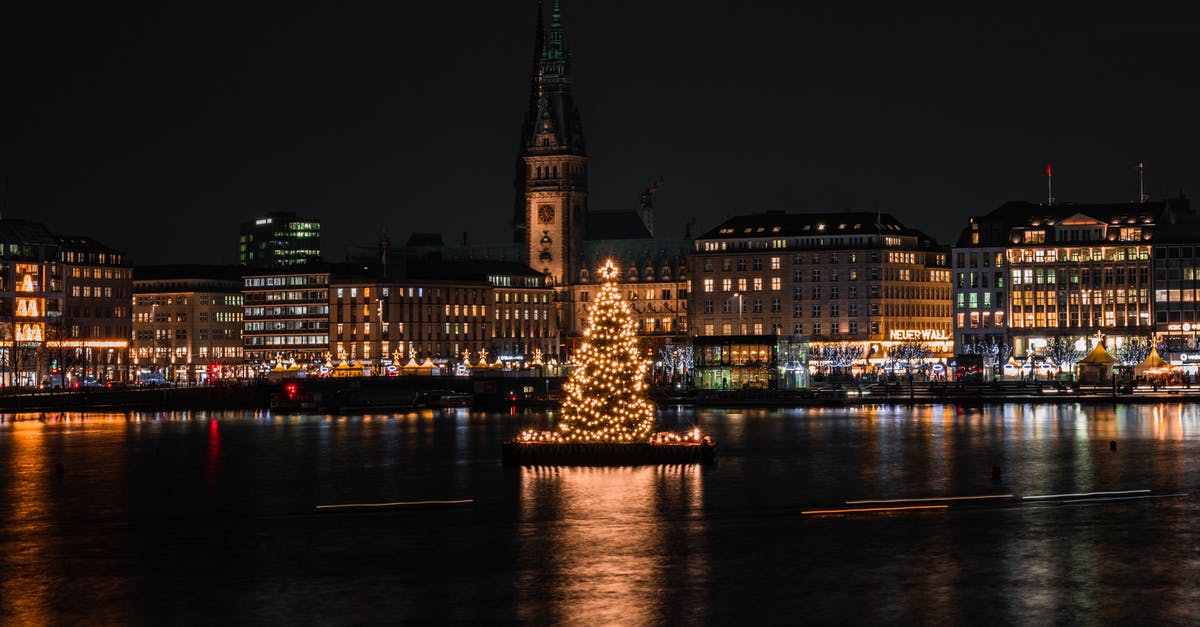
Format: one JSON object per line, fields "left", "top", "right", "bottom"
{"left": 514, "top": 0, "right": 588, "bottom": 285}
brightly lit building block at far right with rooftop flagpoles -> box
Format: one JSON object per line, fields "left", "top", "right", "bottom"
{"left": 952, "top": 198, "right": 1192, "bottom": 368}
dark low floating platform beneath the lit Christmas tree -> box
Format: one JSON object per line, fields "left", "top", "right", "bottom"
{"left": 504, "top": 438, "right": 716, "bottom": 466}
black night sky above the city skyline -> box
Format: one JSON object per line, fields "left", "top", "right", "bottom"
{"left": 9, "top": 0, "right": 1200, "bottom": 263}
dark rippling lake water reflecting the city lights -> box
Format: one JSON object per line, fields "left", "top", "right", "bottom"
{"left": 0, "top": 405, "right": 1200, "bottom": 625}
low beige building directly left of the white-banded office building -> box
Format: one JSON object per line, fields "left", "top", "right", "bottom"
{"left": 131, "top": 265, "right": 248, "bottom": 383}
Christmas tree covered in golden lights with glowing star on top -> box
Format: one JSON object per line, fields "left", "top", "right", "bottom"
{"left": 558, "top": 261, "right": 654, "bottom": 442}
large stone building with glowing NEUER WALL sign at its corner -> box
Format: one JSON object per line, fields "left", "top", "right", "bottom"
{"left": 688, "top": 211, "right": 952, "bottom": 372}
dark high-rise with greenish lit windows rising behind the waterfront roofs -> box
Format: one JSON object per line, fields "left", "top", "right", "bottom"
{"left": 238, "top": 211, "right": 320, "bottom": 268}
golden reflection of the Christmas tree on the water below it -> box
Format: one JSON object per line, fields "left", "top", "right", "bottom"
{"left": 518, "top": 466, "right": 709, "bottom": 625}
